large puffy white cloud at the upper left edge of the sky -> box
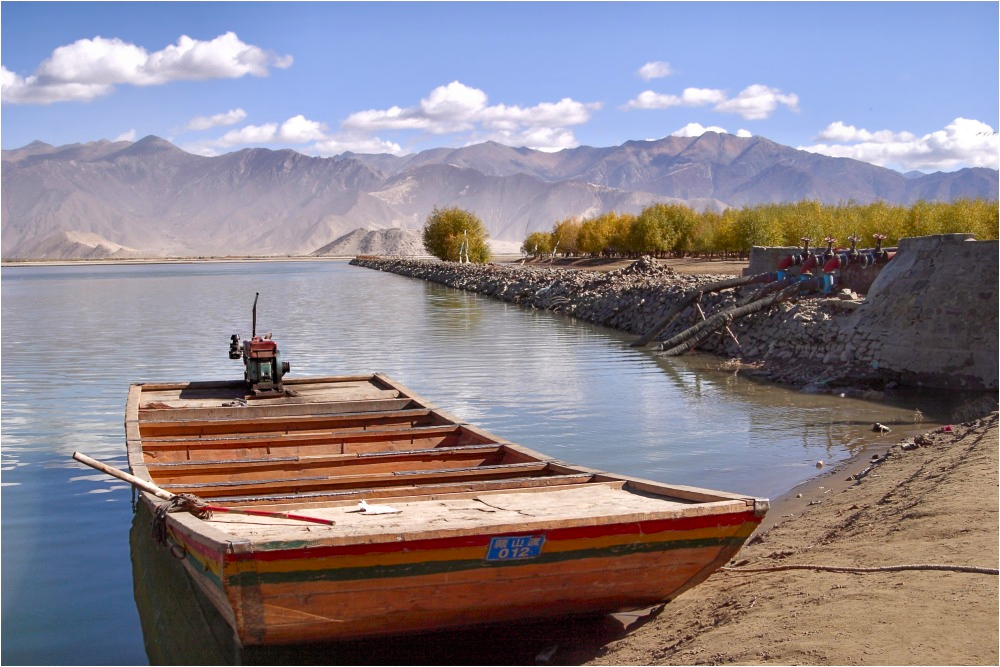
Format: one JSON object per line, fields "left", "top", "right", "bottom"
{"left": 0, "top": 32, "right": 292, "bottom": 104}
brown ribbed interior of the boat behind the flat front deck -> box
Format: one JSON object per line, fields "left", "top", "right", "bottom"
{"left": 130, "top": 375, "right": 722, "bottom": 508}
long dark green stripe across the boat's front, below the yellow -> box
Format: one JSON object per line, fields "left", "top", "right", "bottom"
{"left": 228, "top": 537, "right": 745, "bottom": 586}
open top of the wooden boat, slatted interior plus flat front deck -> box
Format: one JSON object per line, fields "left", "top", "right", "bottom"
{"left": 126, "top": 374, "right": 756, "bottom": 543}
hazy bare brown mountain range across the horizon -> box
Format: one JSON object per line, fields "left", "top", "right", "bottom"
{"left": 0, "top": 132, "right": 1000, "bottom": 259}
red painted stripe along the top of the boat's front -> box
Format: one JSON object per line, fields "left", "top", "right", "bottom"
{"left": 226, "top": 510, "right": 761, "bottom": 562}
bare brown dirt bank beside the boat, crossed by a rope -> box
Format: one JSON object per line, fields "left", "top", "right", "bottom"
{"left": 576, "top": 413, "right": 1000, "bottom": 665}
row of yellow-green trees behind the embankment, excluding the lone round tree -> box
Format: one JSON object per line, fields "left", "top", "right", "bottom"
{"left": 521, "top": 199, "right": 1000, "bottom": 257}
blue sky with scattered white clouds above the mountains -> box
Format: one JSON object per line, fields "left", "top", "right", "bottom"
{"left": 0, "top": 1, "right": 1000, "bottom": 171}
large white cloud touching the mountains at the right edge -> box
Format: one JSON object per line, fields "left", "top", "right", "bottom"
{"left": 798, "top": 118, "right": 1000, "bottom": 171}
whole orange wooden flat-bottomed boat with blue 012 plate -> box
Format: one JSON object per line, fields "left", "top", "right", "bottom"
{"left": 125, "top": 370, "right": 768, "bottom": 646}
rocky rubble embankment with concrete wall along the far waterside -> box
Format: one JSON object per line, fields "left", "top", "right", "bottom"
{"left": 352, "top": 237, "right": 998, "bottom": 392}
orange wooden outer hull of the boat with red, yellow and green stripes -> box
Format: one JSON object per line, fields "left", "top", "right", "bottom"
{"left": 145, "top": 496, "right": 761, "bottom": 646}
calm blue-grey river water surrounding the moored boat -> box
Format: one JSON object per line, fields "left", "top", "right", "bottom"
{"left": 0, "top": 261, "right": 968, "bottom": 665}
